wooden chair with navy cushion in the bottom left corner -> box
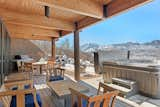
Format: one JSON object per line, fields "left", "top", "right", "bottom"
{"left": 0, "top": 80, "right": 42, "bottom": 107}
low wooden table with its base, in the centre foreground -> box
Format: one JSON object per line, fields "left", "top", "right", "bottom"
{"left": 47, "top": 79, "right": 89, "bottom": 107}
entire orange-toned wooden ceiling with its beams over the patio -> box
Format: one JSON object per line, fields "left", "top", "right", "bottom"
{"left": 0, "top": 0, "right": 151, "bottom": 40}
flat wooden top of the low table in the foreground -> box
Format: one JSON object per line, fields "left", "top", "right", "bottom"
{"left": 47, "top": 80, "right": 89, "bottom": 97}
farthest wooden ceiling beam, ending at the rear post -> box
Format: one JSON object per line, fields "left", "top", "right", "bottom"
{"left": 9, "top": 32, "right": 51, "bottom": 41}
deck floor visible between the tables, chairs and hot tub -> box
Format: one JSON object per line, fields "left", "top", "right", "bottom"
{"left": 5, "top": 70, "right": 160, "bottom": 107}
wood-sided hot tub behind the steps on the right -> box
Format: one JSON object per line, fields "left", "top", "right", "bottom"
{"left": 103, "top": 62, "right": 160, "bottom": 98}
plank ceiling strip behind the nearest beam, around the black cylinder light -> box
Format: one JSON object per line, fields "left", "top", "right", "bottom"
{"left": 0, "top": 0, "right": 85, "bottom": 22}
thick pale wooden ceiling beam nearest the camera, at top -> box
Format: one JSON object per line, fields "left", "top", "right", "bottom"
{"left": 37, "top": 0, "right": 103, "bottom": 19}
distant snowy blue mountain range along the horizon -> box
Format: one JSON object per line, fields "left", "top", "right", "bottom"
{"left": 81, "top": 40, "right": 160, "bottom": 53}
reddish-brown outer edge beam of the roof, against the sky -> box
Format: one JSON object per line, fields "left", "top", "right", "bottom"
{"left": 78, "top": 0, "right": 152, "bottom": 29}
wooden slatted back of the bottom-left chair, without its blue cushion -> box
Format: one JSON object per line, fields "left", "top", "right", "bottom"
{"left": 0, "top": 80, "right": 39, "bottom": 107}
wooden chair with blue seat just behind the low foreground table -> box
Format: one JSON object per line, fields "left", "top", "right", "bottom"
{"left": 46, "top": 61, "right": 65, "bottom": 81}
